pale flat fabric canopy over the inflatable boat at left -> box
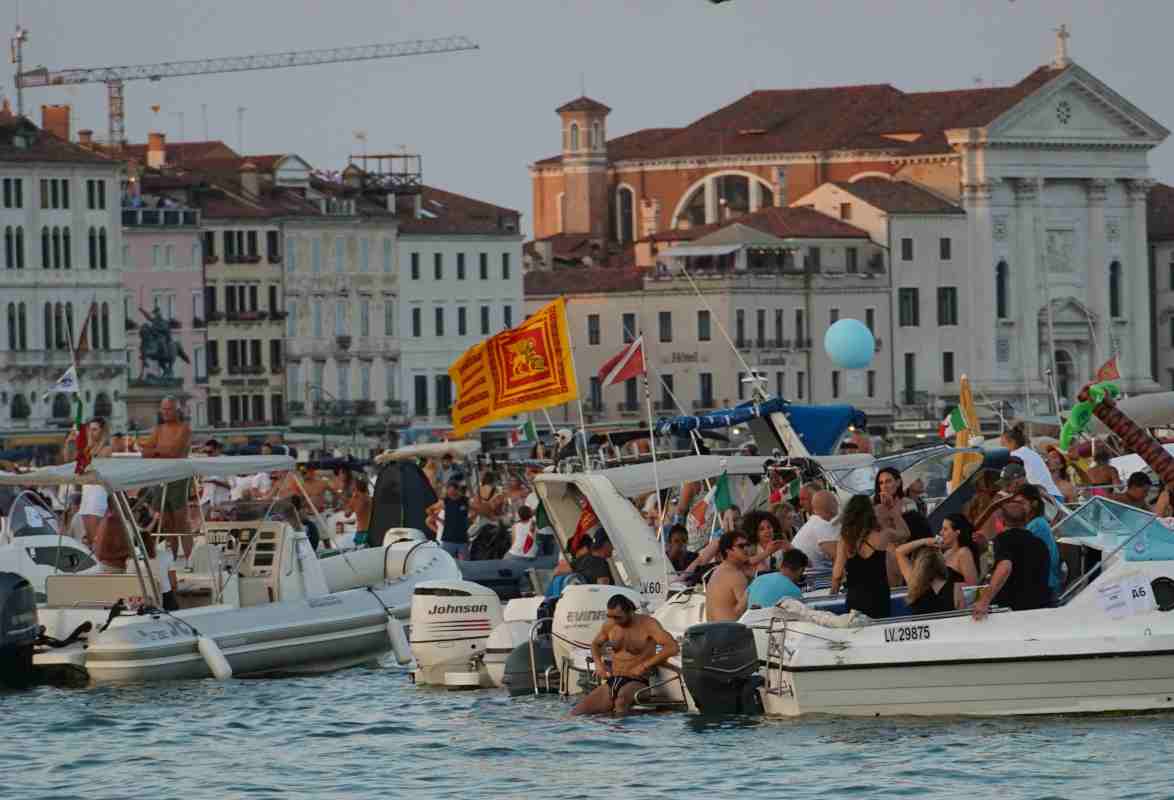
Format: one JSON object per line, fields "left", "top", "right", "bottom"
{"left": 0, "top": 456, "right": 295, "bottom": 491}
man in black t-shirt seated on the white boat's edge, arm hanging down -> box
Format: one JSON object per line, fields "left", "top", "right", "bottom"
{"left": 973, "top": 492, "right": 1051, "bottom": 620}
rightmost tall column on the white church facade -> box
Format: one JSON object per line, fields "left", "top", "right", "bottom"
{"left": 1121, "top": 180, "right": 1154, "bottom": 391}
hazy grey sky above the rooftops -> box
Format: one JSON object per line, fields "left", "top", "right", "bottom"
{"left": 9, "top": 0, "right": 1174, "bottom": 230}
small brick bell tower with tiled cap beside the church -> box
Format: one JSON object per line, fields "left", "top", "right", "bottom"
{"left": 555, "top": 98, "right": 612, "bottom": 242}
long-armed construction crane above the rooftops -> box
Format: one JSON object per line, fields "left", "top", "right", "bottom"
{"left": 12, "top": 34, "right": 479, "bottom": 148}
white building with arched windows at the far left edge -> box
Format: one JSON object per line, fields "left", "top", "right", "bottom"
{"left": 0, "top": 102, "right": 127, "bottom": 460}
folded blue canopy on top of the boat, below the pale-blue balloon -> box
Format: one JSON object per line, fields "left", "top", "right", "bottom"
{"left": 656, "top": 397, "right": 868, "bottom": 456}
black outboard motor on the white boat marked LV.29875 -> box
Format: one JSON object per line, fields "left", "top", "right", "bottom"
{"left": 681, "top": 623, "right": 762, "bottom": 714}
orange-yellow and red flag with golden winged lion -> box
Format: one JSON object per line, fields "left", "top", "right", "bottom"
{"left": 448, "top": 297, "right": 579, "bottom": 437}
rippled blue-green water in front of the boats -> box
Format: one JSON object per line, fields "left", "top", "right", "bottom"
{"left": 0, "top": 666, "right": 1174, "bottom": 800}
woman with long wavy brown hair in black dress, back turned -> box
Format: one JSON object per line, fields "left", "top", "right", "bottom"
{"left": 831, "top": 495, "right": 899, "bottom": 619}
